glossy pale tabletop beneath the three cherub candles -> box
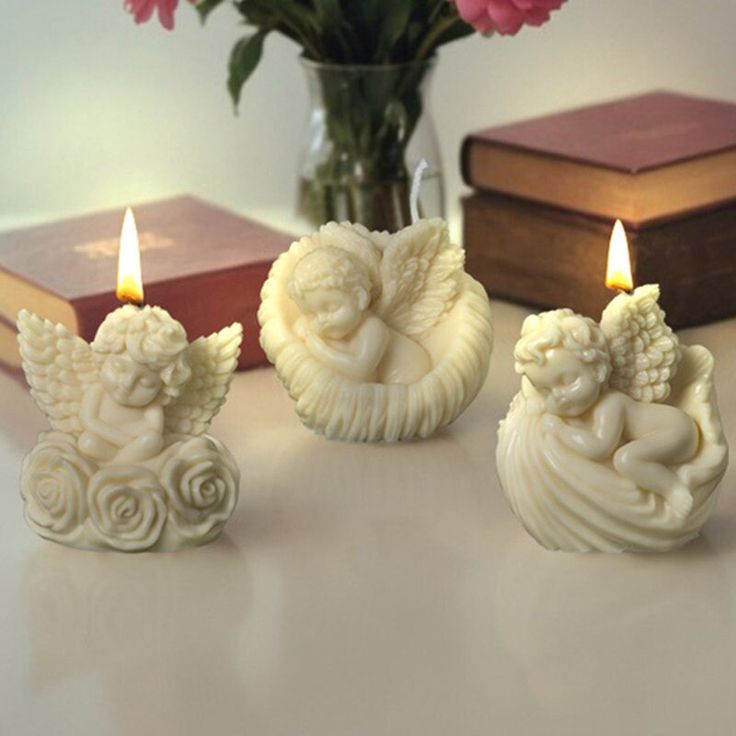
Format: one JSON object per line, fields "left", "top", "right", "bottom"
{"left": 0, "top": 302, "right": 736, "bottom": 736}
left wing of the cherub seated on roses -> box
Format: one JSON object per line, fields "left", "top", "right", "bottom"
{"left": 17, "top": 309, "right": 98, "bottom": 436}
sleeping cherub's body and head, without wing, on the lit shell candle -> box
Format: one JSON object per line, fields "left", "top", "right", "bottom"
{"left": 514, "top": 309, "right": 698, "bottom": 518}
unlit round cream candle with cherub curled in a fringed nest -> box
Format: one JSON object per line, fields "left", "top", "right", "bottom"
{"left": 258, "top": 219, "right": 493, "bottom": 441}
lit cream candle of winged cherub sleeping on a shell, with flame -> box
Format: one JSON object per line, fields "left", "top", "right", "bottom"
{"left": 496, "top": 222, "right": 728, "bottom": 552}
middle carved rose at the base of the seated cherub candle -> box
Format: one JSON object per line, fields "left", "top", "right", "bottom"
{"left": 87, "top": 465, "right": 166, "bottom": 552}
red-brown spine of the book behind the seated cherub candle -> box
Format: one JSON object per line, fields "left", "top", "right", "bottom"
{"left": 73, "top": 263, "right": 271, "bottom": 370}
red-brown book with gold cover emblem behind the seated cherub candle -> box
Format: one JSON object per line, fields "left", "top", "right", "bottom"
{"left": 0, "top": 197, "right": 292, "bottom": 368}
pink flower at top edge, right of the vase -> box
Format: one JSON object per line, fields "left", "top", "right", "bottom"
{"left": 455, "top": 0, "right": 565, "bottom": 35}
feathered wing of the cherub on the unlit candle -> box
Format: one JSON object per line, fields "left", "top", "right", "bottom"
{"left": 375, "top": 218, "right": 465, "bottom": 335}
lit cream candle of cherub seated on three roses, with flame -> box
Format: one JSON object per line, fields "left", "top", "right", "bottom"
{"left": 18, "top": 210, "right": 242, "bottom": 552}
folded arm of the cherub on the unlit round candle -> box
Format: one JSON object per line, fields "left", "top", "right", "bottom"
{"left": 305, "top": 315, "right": 391, "bottom": 381}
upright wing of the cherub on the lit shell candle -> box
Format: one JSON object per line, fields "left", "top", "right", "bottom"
{"left": 600, "top": 284, "right": 682, "bottom": 402}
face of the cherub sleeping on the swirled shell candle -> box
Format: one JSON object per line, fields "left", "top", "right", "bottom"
{"left": 524, "top": 348, "right": 601, "bottom": 417}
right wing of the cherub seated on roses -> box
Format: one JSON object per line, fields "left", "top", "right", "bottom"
{"left": 165, "top": 322, "right": 243, "bottom": 435}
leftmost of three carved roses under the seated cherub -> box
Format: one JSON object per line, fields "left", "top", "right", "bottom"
{"left": 21, "top": 432, "right": 94, "bottom": 540}
